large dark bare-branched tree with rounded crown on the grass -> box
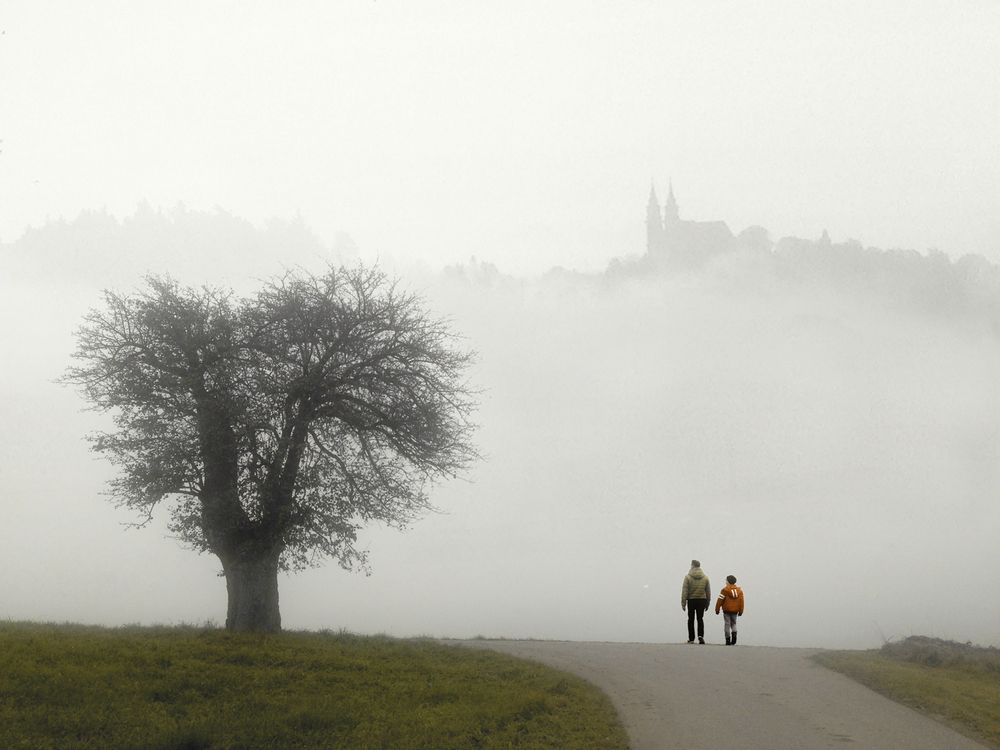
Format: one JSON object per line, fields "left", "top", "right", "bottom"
{"left": 65, "top": 268, "right": 475, "bottom": 631}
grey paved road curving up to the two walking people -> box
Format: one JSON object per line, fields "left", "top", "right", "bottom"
{"left": 465, "top": 641, "right": 984, "bottom": 750}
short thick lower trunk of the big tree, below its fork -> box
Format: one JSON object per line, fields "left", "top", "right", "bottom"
{"left": 222, "top": 552, "right": 281, "bottom": 633}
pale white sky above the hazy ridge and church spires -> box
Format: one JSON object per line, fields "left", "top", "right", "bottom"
{"left": 0, "top": 0, "right": 1000, "bottom": 272}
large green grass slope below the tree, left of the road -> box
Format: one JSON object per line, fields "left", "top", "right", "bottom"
{"left": 0, "top": 622, "right": 628, "bottom": 750}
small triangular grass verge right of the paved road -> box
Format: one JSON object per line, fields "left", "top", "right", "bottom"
{"left": 814, "top": 636, "right": 1000, "bottom": 748}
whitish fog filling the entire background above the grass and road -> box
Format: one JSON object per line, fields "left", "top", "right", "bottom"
{"left": 0, "top": 0, "right": 1000, "bottom": 647}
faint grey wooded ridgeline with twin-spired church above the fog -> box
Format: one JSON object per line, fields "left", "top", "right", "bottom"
{"left": 0, "top": 198, "right": 1000, "bottom": 330}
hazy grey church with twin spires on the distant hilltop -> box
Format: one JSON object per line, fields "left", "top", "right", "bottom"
{"left": 646, "top": 183, "right": 736, "bottom": 268}
